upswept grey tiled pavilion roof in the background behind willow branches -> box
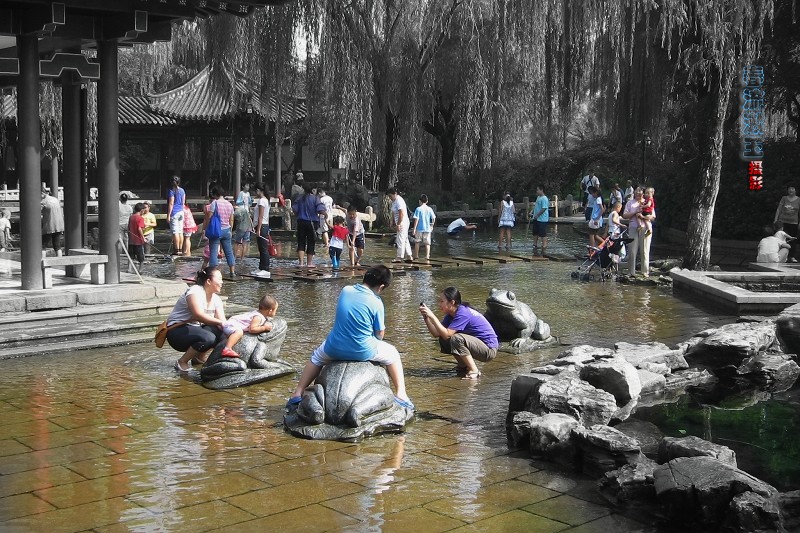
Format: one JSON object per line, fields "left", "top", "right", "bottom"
{"left": 147, "top": 67, "right": 306, "bottom": 122}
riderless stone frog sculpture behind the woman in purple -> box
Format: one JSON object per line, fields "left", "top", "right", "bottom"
{"left": 484, "top": 289, "right": 558, "bottom": 353}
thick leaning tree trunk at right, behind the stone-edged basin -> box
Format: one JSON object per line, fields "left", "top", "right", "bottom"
{"left": 683, "top": 70, "right": 735, "bottom": 270}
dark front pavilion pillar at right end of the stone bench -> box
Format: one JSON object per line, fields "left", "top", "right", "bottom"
{"left": 97, "top": 41, "right": 119, "bottom": 284}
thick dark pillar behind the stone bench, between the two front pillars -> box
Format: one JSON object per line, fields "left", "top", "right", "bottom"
{"left": 61, "top": 76, "right": 85, "bottom": 252}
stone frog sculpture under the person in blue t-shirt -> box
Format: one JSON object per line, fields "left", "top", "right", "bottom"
{"left": 283, "top": 361, "right": 414, "bottom": 442}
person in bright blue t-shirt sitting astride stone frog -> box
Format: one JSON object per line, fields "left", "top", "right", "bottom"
{"left": 286, "top": 265, "right": 414, "bottom": 410}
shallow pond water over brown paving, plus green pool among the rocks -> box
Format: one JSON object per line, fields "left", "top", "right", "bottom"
{"left": 0, "top": 223, "right": 800, "bottom": 531}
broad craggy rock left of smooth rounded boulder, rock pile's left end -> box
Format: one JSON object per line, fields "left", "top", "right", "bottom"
{"left": 526, "top": 374, "right": 617, "bottom": 426}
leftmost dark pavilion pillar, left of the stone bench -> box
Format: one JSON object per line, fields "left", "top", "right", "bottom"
{"left": 17, "top": 35, "right": 44, "bottom": 290}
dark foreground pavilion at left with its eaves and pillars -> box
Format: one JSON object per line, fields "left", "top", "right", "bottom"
{"left": 0, "top": 0, "right": 285, "bottom": 290}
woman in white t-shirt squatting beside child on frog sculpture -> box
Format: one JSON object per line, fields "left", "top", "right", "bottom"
{"left": 167, "top": 267, "right": 226, "bottom": 372}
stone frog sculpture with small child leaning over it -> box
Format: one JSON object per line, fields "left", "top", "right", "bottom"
{"left": 200, "top": 317, "right": 295, "bottom": 389}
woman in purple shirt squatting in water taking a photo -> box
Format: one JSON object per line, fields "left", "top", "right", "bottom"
{"left": 419, "top": 287, "right": 500, "bottom": 379}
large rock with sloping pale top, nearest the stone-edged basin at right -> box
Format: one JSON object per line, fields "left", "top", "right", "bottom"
{"left": 686, "top": 320, "right": 775, "bottom": 368}
